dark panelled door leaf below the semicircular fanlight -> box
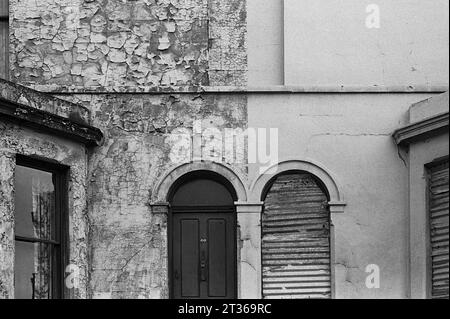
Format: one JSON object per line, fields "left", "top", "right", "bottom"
{"left": 171, "top": 213, "right": 236, "bottom": 299}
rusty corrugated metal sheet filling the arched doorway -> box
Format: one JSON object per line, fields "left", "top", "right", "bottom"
{"left": 262, "top": 173, "right": 331, "bottom": 299}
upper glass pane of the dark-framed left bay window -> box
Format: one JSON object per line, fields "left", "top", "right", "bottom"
{"left": 15, "top": 165, "right": 55, "bottom": 239}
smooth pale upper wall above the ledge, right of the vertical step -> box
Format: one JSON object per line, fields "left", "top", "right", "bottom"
{"left": 284, "top": 0, "right": 449, "bottom": 87}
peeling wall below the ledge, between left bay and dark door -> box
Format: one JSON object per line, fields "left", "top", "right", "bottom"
{"left": 56, "top": 94, "right": 247, "bottom": 298}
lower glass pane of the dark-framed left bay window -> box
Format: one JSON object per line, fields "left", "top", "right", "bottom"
{"left": 14, "top": 241, "right": 52, "bottom": 299}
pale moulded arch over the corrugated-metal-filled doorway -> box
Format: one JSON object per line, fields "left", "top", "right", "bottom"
{"left": 249, "top": 160, "right": 346, "bottom": 213}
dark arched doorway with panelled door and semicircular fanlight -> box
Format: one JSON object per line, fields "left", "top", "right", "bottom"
{"left": 168, "top": 171, "right": 237, "bottom": 299}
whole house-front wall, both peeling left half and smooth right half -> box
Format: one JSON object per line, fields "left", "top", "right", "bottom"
{"left": 5, "top": 0, "right": 448, "bottom": 298}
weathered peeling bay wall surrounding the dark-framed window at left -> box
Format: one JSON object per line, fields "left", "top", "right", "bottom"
{"left": 0, "top": 123, "right": 89, "bottom": 299}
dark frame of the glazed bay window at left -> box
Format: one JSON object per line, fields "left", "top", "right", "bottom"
{"left": 14, "top": 154, "right": 69, "bottom": 299}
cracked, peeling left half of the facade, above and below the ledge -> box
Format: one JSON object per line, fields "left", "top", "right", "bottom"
{"left": 5, "top": 0, "right": 247, "bottom": 298}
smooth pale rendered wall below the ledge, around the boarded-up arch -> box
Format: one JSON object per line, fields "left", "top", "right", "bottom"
{"left": 248, "top": 94, "right": 438, "bottom": 298}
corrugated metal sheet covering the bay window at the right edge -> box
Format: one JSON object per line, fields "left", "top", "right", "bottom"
{"left": 429, "top": 160, "right": 449, "bottom": 299}
